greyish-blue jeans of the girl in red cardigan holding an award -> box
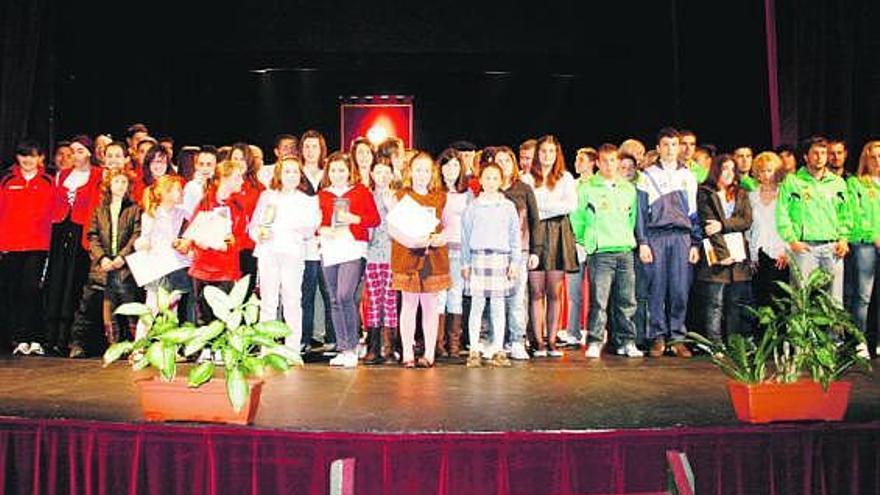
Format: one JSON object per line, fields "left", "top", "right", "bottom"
{"left": 323, "top": 258, "right": 364, "bottom": 351}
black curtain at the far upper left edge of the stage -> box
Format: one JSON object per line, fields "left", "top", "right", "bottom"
{"left": 0, "top": 0, "right": 51, "bottom": 168}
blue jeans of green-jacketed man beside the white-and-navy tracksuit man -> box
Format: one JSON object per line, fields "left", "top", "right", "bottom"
{"left": 587, "top": 251, "right": 636, "bottom": 344}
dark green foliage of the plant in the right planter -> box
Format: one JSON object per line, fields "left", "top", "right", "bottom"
{"left": 688, "top": 263, "right": 871, "bottom": 389}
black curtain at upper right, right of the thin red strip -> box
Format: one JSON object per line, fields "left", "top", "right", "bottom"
{"left": 776, "top": 0, "right": 880, "bottom": 154}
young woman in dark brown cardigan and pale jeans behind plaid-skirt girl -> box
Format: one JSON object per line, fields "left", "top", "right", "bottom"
{"left": 495, "top": 146, "right": 544, "bottom": 360}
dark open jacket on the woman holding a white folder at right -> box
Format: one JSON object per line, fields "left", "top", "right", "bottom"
{"left": 697, "top": 185, "right": 752, "bottom": 283}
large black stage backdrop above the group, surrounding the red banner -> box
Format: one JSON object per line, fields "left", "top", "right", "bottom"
{"left": 0, "top": 0, "right": 769, "bottom": 165}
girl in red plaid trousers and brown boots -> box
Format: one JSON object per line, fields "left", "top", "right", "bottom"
{"left": 364, "top": 162, "right": 397, "bottom": 364}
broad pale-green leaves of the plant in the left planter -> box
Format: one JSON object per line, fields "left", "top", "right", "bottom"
{"left": 104, "top": 275, "right": 303, "bottom": 411}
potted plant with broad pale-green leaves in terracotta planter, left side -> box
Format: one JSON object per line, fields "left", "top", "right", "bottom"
{"left": 104, "top": 276, "right": 302, "bottom": 424}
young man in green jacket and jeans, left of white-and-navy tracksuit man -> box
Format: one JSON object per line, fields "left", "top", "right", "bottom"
{"left": 571, "top": 144, "right": 643, "bottom": 358}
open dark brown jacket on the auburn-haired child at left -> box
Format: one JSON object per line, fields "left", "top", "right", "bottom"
{"left": 88, "top": 200, "right": 141, "bottom": 285}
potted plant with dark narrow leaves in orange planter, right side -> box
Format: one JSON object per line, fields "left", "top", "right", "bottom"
{"left": 688, "top": 263, "right": 870, "bottom": 423}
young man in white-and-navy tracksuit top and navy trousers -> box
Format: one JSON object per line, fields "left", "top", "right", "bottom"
{"left": 636, "top": 127, "right": 700, "bottom": 358}
